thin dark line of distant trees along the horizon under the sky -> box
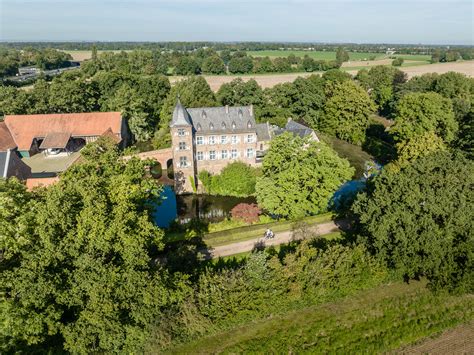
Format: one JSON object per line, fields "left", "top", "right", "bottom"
{"left": 2, "top": 42, "right": 472, "bottom": 54}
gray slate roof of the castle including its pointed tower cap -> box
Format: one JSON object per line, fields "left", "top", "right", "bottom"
{"left": 170, "top": 100, "right": 256, "bottom": 134}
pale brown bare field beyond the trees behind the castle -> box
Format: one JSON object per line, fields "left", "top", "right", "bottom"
{"left": 170, "top": 61, "right": 474, "bottom": 91}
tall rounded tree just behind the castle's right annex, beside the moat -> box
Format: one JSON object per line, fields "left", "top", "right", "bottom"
{"left": 320, "top": 81, "right": 375, "bottom": 144}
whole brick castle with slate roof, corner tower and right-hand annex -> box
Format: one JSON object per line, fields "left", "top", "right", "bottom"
{"left": 170, "top": 99, "right": 318, "bottom": 193}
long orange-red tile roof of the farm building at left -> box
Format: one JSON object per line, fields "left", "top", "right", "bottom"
{"left": 4, "top": 112, "right": 122, "bottom": 150}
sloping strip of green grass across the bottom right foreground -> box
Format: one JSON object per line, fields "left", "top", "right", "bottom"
{"left": 170, "top": 281, "right": 474, "bottom": 354}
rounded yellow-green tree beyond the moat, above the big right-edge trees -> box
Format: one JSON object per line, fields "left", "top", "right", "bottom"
{"left": 390, "top": 92, "right": 458, "bottom": 143}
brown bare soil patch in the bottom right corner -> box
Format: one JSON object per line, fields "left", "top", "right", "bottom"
{"left": 397, "top": 323, "right": 474, "bottom": 355}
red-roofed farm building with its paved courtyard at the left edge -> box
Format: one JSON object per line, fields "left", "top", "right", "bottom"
{"left": 0, "top": 112, "right": 128, "bottom": 185}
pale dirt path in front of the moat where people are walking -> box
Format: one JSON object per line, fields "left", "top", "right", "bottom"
{"left": 204, "top": 221, "right": 344, "bottom": 259}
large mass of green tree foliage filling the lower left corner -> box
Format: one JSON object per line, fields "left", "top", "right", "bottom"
{"left": 0, "top": 138, "right": 187, "bottom": 353}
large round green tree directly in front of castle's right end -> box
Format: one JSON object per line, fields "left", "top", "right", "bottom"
{"left": 256, "top": 133, "right": 354, "bottom": 218}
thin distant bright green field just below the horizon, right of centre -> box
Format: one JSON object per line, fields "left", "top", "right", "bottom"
{"left": 247, "top": 50, "right": 431, "bottom": 61}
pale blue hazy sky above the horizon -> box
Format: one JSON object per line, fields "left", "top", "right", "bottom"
{"left": 0, "top": 0, "right": 474, "bottom": 45}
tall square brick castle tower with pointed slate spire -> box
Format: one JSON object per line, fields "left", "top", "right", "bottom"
{"left": 170, "top": 98, "right": 196, "bottom": 194}
